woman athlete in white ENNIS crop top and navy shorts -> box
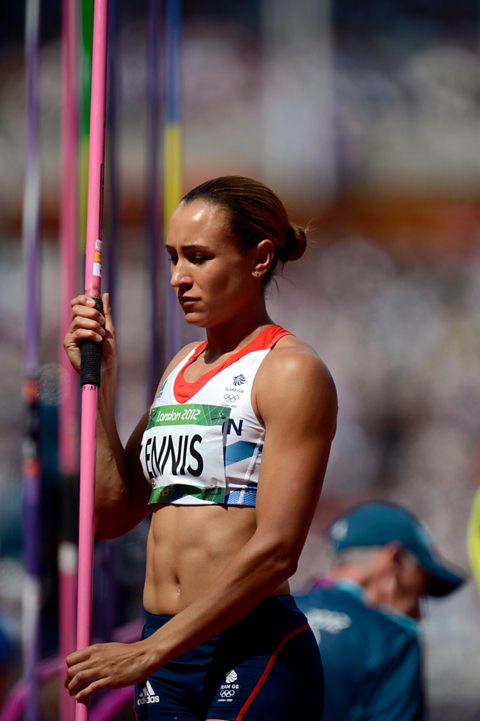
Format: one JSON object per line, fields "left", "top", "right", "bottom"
{"left": 65, "top": 176, "right": 337, "bottom": 721}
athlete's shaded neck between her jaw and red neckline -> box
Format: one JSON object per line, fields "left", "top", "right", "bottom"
{"left": 205, "top": 305, "right": 272, "bottom": 363}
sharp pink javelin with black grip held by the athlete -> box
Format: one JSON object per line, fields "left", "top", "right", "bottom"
{"left": 75, "top": 0, "right": 108, "bottom": 721}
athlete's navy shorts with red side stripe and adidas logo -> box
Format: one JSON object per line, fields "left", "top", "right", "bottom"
{"left": 135, "top": 595, "right": 323, "bottom": 721}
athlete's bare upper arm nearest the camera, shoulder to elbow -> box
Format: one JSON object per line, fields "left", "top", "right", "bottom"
{"left": 257, "top": 356, "right": 337, "bottom": 558}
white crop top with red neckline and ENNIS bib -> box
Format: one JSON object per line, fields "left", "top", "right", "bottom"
{"left": 140, "top": 325, "right": 290, "bottom": 506}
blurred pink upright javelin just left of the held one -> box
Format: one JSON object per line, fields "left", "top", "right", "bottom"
{"left": 58, "top": 0, "right": 78, "bottom": 721}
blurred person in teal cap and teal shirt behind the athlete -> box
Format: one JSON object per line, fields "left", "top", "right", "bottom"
{"left": 296, "top": 501, "right": 464, "bottom": 721}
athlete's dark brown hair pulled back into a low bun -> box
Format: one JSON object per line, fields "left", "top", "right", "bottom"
{"left": 182, "top": 175, "right": 307, "bottom": 281}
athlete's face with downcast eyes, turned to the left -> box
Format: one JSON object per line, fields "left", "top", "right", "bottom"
{"left": 166, "top": 200, "right": 261, "bottom": 328}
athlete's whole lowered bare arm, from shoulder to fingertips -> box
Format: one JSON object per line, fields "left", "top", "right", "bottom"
{"left": 69, "top": 344, "right": 337, "bottom": 698}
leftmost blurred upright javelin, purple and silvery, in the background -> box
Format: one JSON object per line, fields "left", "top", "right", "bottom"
{"left": 22, "top": 0, "right": 41, "bottom": 721}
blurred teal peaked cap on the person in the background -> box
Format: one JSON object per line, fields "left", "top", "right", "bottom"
{"left": 328, "top": 501, "right": 465, "bottom": 596}
